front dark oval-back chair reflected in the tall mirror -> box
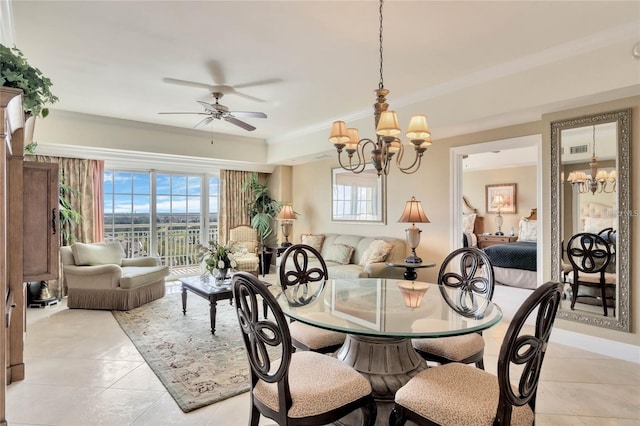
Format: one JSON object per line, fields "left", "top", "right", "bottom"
{"left": 567, "top": 232, "right": 617, "bottom": 317}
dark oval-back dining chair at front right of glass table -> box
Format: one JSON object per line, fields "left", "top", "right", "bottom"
{"left": 389, "top": 282, "right": 562, "bottom": 426}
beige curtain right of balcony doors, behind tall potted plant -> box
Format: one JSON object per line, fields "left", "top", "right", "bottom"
{"left": 218, "top": 170, "right": 253, "bottom": 244}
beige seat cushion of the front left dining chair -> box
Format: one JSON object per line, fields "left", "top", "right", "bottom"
{"left": 253, "top": 351, "right": 371, "bottom": 418}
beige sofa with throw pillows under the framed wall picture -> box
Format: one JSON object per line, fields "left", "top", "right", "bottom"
{"left": 276, "top": 233, "right": 407, "bottom": 279}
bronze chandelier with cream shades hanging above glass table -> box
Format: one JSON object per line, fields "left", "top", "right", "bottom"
{"left": 329, "top": 0, "right": 431, "bottom": 176}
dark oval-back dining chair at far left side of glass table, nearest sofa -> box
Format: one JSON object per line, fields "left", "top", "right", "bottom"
{"left": 279, "top": 244, "right": 346, "bottom": 353}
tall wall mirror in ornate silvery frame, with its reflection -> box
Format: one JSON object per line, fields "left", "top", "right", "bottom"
{"left": 552, "top": 111, "right": 629, "bottom": 330}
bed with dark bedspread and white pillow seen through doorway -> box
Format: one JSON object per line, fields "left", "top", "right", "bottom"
{"left": 484, "top": 209, "right": 538, "bottom": 289}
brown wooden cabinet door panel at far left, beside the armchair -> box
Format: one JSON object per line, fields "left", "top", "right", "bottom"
{"left": 23, "top": 161, "right": 59, "bottom": 282}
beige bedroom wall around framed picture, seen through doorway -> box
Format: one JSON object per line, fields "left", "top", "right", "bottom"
{"left": 462, "top": 166, "right": 538, "bottom": 236}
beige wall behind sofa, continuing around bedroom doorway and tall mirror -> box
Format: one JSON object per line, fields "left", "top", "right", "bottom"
{"left": 292, "top": 97, "right": 640, "bottom": 346}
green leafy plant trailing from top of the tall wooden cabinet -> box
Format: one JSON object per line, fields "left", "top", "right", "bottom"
{"left": 0, "top": 44, "right": 58, "bottom": 118}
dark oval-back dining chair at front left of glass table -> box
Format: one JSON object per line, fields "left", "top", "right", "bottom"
{"left": 231, "top": 272, "right": 377, "bottom": 426}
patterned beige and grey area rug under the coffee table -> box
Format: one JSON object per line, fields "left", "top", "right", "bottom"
{"left": 113, "top": 293, "right": 250, "bottom": 413}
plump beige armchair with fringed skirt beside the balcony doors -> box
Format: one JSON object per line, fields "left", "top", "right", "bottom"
{"left": 60, "top": 242, "right": 169, "bottom": 311}
